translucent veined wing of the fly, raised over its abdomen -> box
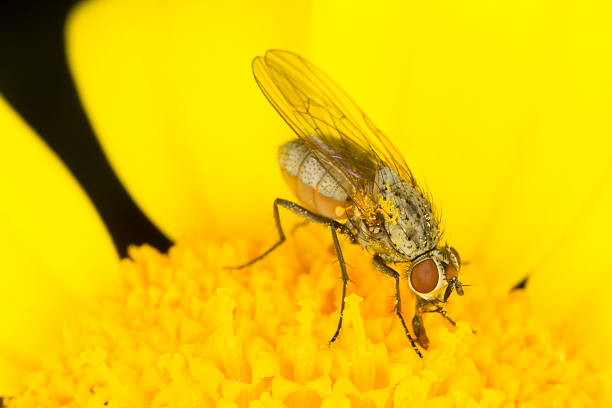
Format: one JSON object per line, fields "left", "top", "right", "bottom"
{"left": 253, "top": 50, "right": 418, "bottom": 225}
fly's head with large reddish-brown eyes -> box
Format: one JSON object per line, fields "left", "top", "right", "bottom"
{"left": 407, "top": 246, "right": 463, "bottom": 303}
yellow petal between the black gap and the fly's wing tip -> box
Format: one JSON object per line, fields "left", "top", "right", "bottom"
{"left": 67, "top": 0, "right": 308, "bottom": 242}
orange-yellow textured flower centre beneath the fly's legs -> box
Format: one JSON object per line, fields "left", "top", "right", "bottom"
{"left": 11, "top": 227, "right": 610, "bottom": 407}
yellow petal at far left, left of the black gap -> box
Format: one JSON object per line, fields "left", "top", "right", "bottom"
{"left": 0, "top": 98, "right": 118, "bottom": 395}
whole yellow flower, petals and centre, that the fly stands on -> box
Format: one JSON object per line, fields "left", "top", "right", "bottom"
{"left": 0, "top": 0, "right": 612, "bottom": 407}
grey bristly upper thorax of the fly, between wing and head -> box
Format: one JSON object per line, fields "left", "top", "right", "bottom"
{"left": 376, "top": 167, "right": 439, "bottom": 259}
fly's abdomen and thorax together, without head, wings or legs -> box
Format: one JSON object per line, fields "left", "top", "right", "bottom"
{"left": 279, "top": 140, "right": 439, "bottom": 263}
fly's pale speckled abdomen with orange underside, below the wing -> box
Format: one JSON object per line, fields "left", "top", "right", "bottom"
{"left": 279, "top": 140, "right": 352, "bottom": 219}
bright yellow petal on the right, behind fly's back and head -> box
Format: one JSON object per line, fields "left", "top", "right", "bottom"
{"left": 311, "top": 1, "right": 612, "bottom": 295}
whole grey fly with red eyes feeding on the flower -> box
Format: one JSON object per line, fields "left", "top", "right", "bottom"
{"left": 227, "top": 50, "right": 463, "bottom": 357}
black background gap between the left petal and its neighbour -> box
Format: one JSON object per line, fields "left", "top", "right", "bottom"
{"left": 0, "top": 0, "right": 172, "bottom": 256}
